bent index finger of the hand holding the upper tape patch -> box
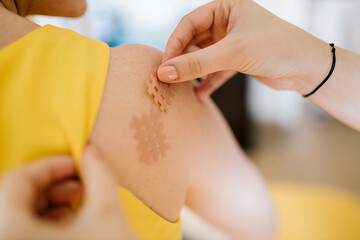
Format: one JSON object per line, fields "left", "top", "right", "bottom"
{"left": 163, "top": 2, "right": 214, "bottom": 62}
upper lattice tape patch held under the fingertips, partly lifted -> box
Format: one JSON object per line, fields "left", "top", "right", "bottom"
{"left": 146, "top": 71, "right": 175, "bottom": 112}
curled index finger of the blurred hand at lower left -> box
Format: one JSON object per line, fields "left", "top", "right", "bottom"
{"left": 1, "top": 156, "right": 76, "bottom": 211}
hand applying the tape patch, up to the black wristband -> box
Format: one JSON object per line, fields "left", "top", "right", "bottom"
{"left": 158, "top": 0, "right": 331, "bottom": 98}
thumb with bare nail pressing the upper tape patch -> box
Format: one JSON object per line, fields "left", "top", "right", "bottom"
{"left": 157, "top": 40, "right": 230, "bottom": 83}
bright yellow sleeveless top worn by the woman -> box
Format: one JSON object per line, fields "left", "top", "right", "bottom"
{"left": 0, "top": 25, "right": 181, "bottom": 240}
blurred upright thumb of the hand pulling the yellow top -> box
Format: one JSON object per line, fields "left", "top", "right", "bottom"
{"left": 82, "top": 145, "right": 119, "bottom": 212}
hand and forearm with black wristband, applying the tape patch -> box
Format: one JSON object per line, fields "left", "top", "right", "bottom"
{"left": 158, "top": 0, "right": 360, "bottom": 131}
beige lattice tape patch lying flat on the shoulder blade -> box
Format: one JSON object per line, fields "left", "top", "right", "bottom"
{"left": 130, "top": 111, "right": 168, "bottom": 163}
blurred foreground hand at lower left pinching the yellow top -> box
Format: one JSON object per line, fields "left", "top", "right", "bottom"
{"left": 0, "top": 146, "right": 134, "bottom": 240}
